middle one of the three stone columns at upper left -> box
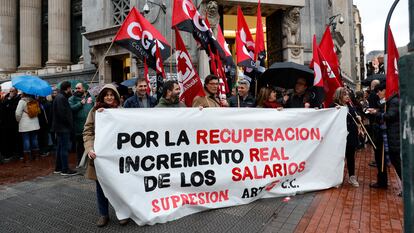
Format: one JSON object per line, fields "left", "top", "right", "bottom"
{"left": 19, "top": 0, "right": 42, "bottom": 70}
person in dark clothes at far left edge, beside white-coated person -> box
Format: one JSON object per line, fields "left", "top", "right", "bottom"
{"left": 0, "top": 87, "right": 22, "bottom": 162}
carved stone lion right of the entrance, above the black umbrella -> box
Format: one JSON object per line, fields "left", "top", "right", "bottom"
{"left": 282, "top": 7, "right": 300, "bottom": 46}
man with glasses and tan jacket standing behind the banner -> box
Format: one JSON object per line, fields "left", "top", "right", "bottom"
{"left": 193, "top": 74, "right": 229, "bottom": 108}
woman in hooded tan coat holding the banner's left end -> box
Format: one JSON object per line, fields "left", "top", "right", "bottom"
{"left": 83, "top": 84, "right": 129, "bottom": 227}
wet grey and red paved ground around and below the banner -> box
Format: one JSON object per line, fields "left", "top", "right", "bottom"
{"left": 0, "top": 149, "right": 403, "bottom": 233}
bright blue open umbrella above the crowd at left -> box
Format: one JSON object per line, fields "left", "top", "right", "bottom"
{"left": 12, "top": 75, "right": 52, "bottom": 96}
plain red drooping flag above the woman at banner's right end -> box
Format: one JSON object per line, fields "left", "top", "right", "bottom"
{"left": 319, "top": 26, "right": 342, "bottom": 81}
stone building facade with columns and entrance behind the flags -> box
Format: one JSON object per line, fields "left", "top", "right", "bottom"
{"left": 0, "top": 0, "right": 360, "bottom": 89}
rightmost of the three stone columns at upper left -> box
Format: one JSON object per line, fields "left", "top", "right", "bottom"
{"left": 46, "top": 0, "right": 70, "bottom": 67}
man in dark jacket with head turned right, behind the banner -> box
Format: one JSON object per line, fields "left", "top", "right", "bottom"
{"left": 155, "top": 80, "right": 185, "bottom": 108}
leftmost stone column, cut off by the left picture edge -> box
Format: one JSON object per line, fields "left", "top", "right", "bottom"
{"left": 0, "top": 0, "right": 17, "bottom": 73}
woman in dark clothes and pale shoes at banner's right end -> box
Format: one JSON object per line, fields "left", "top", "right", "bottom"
{"left": 331, "top": 87, "right": 359, "bottom": 187}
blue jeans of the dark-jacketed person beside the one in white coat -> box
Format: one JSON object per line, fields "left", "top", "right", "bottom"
{"left": 55, "top": 132, "right": 70, "bottom": 172}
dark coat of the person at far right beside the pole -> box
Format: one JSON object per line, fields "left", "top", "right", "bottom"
{"left": 383, "top": 95, "right": 400, "bottom": 153}
